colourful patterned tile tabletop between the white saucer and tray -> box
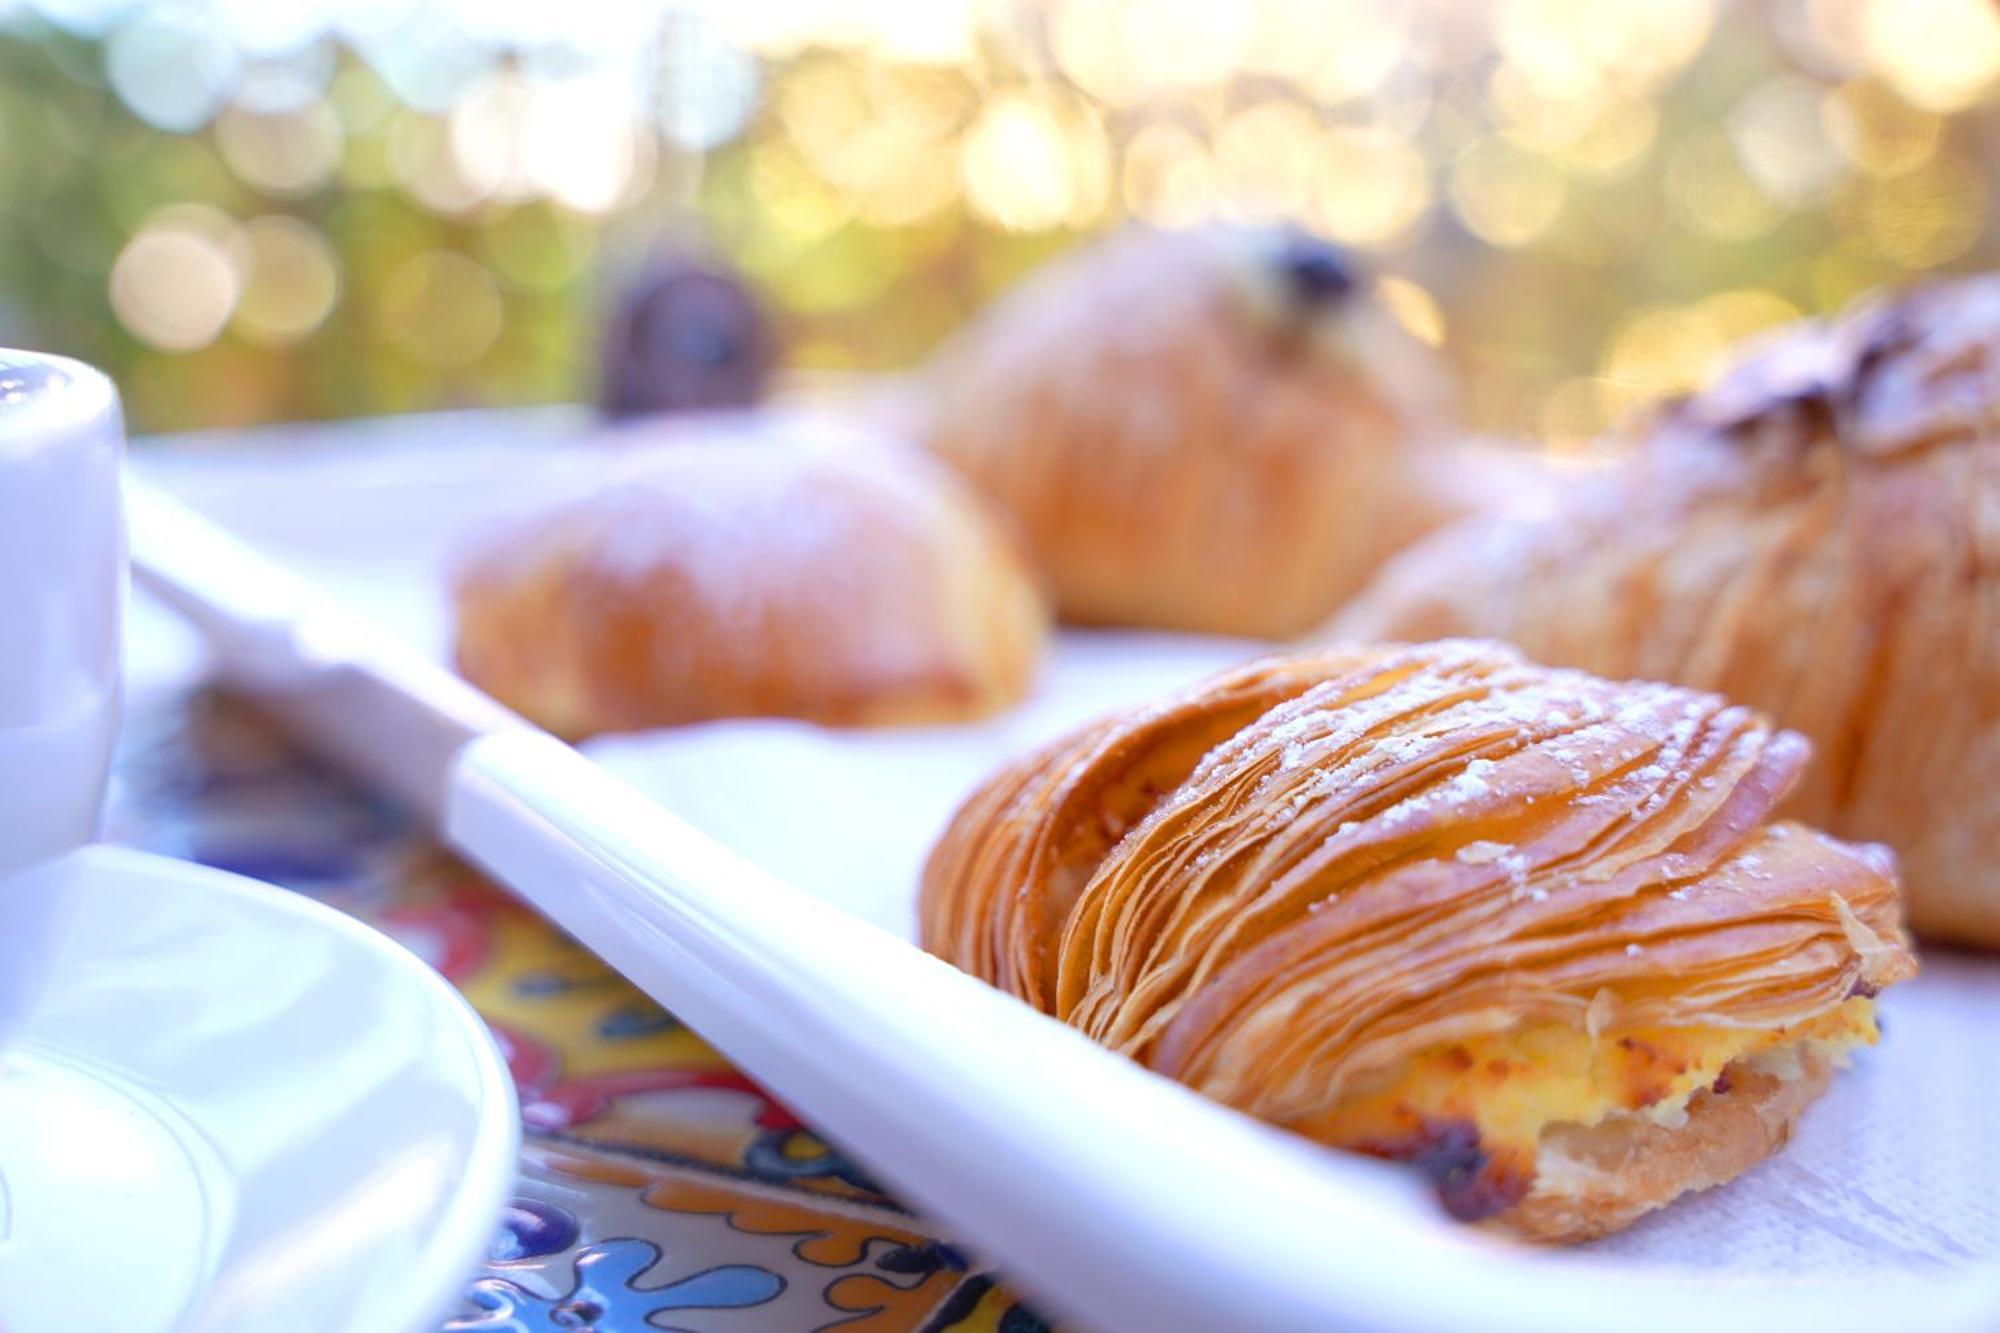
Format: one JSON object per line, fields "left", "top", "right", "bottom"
{"left": 110, "top": 697, "right": 1044, "bottom": 1333}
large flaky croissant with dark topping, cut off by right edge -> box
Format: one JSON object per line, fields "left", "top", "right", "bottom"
{"left": 1332, "top": 276, "right": 2000, "bottom": 947}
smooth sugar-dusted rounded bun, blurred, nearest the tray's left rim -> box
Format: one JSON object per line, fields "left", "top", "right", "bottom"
{"left": 454, "top": 418, "right": 1048, "bottom": 737}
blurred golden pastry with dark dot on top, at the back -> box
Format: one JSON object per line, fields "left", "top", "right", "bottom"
{"left": 926, "top": 226, "right": 1460, "bottom": 636}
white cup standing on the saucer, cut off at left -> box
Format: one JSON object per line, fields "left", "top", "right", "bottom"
{"left": 0, "top": 350, "right": 126, "bottom": 1043}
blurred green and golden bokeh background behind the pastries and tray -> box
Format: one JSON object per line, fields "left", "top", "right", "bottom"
{"left": 0, "top": 0, "right": 2000, "bottom": 448}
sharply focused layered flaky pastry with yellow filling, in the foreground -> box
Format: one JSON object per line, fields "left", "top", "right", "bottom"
{"left": 922, "top": 640, "right": 1914, "bottom": 1241}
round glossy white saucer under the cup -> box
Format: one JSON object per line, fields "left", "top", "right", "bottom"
{"left": 0, "top": 847, "right": 520, "bottom": 1333}
